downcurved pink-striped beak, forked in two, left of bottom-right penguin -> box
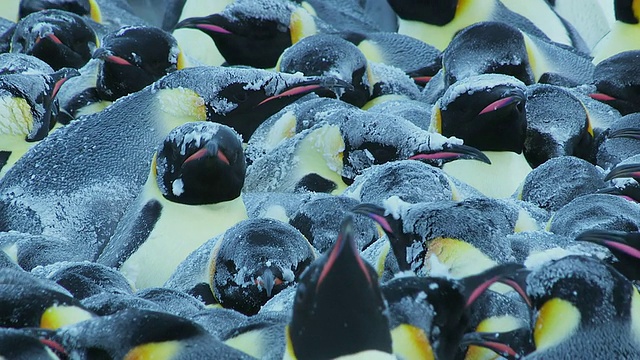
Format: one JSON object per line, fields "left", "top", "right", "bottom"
{"left": 460, "top": 263, "right": 531, "bottom": 308}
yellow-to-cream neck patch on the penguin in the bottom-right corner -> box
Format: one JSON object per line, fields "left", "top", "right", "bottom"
{"left": 533, "top": 298, "right": 581, "bottom": 350}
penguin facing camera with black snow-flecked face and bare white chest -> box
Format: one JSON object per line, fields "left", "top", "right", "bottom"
{"left": 98, "top": 122, "right": 247, "bottom": 289}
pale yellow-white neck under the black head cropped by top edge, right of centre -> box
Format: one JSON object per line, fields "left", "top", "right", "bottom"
{"left": 398, "top": 0, "right": 497, "bottom": 51}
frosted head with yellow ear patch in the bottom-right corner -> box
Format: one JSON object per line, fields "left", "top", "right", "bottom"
{"left": 526, "top": 255, "right": 639, "bottom": 351}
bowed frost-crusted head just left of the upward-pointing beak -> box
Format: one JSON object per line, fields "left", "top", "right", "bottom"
{"left": 210, "top": 218, "right": 316, "bottom": 315}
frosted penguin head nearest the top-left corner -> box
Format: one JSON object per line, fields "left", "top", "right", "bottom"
{"left": 11, "top": 9, "right": 98, "bottom": 70}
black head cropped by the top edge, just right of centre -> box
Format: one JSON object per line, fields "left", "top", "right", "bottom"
{"left": 389, "top": 0, "right": 458, "bottom": 26}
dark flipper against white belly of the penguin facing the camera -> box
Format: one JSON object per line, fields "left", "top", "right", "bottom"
{"left": 97, "top": 200, "right": 162, "bottom": 268}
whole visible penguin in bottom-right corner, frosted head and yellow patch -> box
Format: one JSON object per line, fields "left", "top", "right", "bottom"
{"left": 526, "top": 255, "right": 640, "bottom": 359}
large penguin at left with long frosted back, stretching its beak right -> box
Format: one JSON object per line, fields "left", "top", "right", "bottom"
{"left": 0, "top": 67, "right": 342, "bottom": 266}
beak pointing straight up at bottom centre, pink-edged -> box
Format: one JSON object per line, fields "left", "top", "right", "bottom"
{"left": 316, "top": 215, "right": 373, "bottom": 292}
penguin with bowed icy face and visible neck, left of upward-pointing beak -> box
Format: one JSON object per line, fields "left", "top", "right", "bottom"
{"left": 164, "top": 218, "right": 317, "bottom": 315}
